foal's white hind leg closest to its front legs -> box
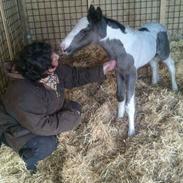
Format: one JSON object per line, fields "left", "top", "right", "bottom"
{"left": 149, "top": 56, "right": 160, "bottom": 84}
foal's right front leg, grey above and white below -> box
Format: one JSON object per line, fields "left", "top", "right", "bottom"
{"left": 126, "top": 66, "right": 137, "bottom": 136}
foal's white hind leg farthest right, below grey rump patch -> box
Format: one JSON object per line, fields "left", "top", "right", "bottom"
{"left": 163, "top": 55, "right": 178, "bottom": 91}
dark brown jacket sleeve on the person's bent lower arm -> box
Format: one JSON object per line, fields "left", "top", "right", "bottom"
{"left": 13, "top": 93, "right": 80, "bottom": 136}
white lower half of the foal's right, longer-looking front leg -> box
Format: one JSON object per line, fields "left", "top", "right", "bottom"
{"left": 126, "top": 95, "right": 135, "bottom": 136}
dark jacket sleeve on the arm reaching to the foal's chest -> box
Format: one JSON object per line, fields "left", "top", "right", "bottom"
{"left": 57, "top": 64, "right": 105, "bottom": 88}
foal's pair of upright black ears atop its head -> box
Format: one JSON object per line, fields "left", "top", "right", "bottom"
{"left": 87, "top": 5, "right": 102, "bottom": 24}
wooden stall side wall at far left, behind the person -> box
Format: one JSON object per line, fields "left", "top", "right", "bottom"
{"left": 0, "top": 0, "right": 24, "bottom": 93}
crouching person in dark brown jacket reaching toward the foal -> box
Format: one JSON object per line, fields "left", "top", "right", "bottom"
{"left": 3, "top": 42, "right": 116, "bottom": 171}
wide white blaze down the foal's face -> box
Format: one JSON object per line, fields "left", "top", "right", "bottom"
{"left": 61, "top": 17, "right": 89, "bottom": 50}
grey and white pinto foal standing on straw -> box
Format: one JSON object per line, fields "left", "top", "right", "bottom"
{"left": 60, "top": 5, "right": 178, "bottom": 136}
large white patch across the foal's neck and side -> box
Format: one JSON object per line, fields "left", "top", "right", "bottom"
{"left": 100, "top": 26, "right": 156, "bottom": 69}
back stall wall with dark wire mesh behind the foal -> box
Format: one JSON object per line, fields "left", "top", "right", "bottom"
{"left": 25, "top": 0, "right": 183, "bottom": 46}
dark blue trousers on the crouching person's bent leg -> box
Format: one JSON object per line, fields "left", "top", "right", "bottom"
{"left": 19, "top": 136, "right": 57, "bottom": 171}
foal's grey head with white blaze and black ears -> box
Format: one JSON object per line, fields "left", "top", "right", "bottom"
{"left": 60, "top": 5, "right": 106, "bottom": 55}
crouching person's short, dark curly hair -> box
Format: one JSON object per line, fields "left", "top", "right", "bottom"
{"left": 15, "top": 42, "right": 52, "bottom": 81}
